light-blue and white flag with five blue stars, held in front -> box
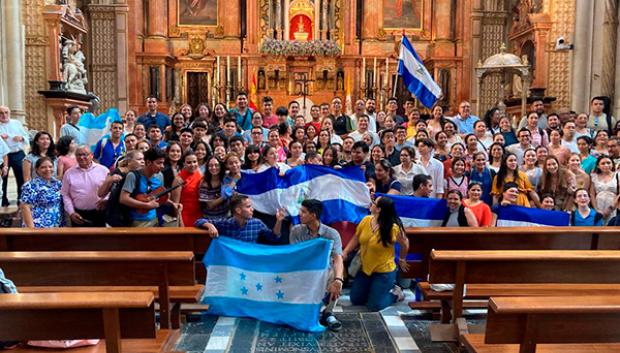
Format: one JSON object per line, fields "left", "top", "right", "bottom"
{"left": 201, "top": 237, "right": 332, "bottom": 332}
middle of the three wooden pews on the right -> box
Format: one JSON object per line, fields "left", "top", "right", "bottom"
{"left": 429, "top": 250, "right": 620, "bottom": 320}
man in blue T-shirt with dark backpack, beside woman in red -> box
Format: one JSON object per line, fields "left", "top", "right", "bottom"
{"left": 120, "top": 148, "right": 166, "bottom": 227}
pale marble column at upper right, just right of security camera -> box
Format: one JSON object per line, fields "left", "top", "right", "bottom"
{"left": 571, "top": 1, "right": 594, "bottom": 112}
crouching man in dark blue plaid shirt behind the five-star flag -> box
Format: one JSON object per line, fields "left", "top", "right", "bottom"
{"left": 195, "top": 194, "right": 284, "bottom": 243}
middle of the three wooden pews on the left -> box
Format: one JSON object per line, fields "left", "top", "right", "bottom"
{"left": 0, "top": 251, "right": 195, "bottom": 329}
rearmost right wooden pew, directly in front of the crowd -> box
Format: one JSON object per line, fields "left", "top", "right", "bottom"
{"left": 406, "top": 227, "right": 620, "bottom": 278}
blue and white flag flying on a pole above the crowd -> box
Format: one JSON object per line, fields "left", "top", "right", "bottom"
{"left": 398, "top": 35, "right": 441, "bottom": 108}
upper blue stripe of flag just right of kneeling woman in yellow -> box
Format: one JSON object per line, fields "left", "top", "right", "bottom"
{"left": 377, "top": 194, "right": 448, "bottom": 220}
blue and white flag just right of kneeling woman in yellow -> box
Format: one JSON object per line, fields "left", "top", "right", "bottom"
{"left": 377, "top": 194, "right": 448, "bottom": 227}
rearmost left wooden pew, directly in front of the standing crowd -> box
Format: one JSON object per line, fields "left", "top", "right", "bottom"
{"left": 0, "top": 227, "right": 211, "bottom": 283}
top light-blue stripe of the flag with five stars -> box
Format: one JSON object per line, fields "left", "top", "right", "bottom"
{"left": 203, "top": 237, "right": 331, "bottom": 273}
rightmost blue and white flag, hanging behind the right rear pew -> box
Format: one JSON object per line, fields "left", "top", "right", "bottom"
{"left": 493, "top": 205, "right": 570, "bottom": 227}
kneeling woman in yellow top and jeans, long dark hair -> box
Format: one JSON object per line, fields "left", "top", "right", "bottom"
{"left": 342, "top": 197, "right": 409, "bottom": 311}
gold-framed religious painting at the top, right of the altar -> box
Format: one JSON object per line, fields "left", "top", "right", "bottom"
{"left": 383, "top": 0, "right": 428, "bottom": 30}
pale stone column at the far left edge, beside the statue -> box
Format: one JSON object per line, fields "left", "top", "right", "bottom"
{"left": 3, "top": 0, "right": 26, "bottom": 122}
